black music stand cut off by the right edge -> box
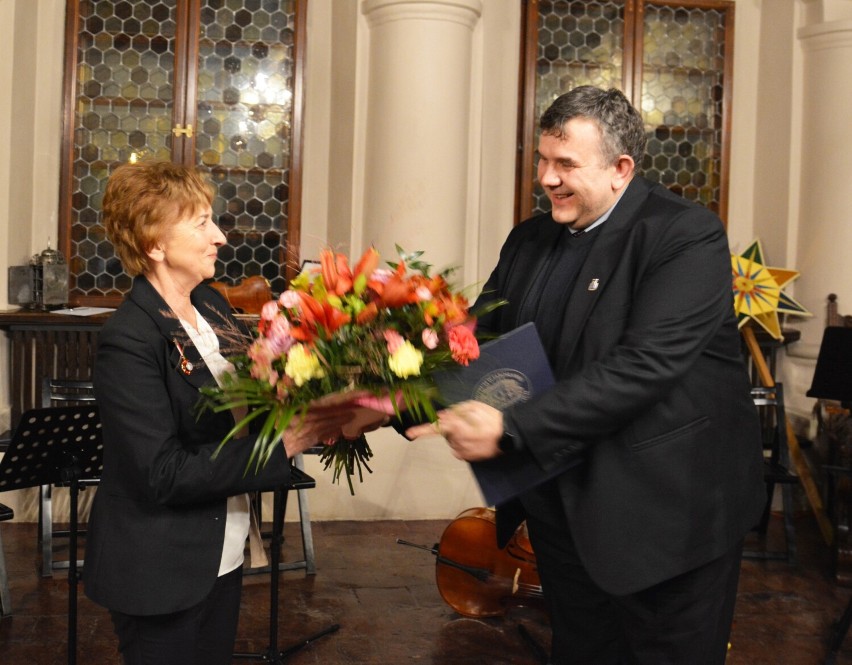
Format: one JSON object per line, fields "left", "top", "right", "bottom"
{"left": 805, "top": 326, "right": 852, "bottom": 665}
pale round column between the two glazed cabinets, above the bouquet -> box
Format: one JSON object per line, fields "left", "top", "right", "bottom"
{"left": 361, "top": 0, "right": 482, "bottom": 269}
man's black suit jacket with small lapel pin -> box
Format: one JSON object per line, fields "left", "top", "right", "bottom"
{"left": 479, "top": 176, "right": 766, "bottom": 595}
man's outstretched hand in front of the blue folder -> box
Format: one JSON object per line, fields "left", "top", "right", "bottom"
{"left": 405, "top": 400, "right": 503, "bottom": 462}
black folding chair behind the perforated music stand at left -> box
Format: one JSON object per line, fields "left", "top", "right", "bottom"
{"left": 38, "top": 377, "right": 100, "bottom": 577}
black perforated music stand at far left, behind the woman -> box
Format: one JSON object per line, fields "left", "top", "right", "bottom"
{"left": 0, "top": 404, "right": 103, "bottom": 665}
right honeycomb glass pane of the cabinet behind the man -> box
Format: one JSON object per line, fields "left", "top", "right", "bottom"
{"left": 641, "top": 5, "right": 726, "bottom": 212}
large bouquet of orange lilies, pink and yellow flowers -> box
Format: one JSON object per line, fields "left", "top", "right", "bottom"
{"left": 196, "top": 246, "right": 479, "bottom": 493}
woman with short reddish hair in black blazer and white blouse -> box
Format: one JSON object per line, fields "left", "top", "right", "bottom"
{"left": 85, "top": 162, "right": 349, "bottom": 665}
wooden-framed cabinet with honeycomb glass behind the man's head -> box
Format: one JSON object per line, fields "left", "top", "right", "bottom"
{"left": 516, "top": 0, "right": 734, "bottom": 221}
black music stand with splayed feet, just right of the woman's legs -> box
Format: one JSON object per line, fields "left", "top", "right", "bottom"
{"left": 233, "top": 466, "right": 340, "bottom": 664}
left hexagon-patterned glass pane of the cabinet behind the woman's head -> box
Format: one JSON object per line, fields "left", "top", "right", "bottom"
{"left": 68, "top": 0, "right": 177, "bottom": 296}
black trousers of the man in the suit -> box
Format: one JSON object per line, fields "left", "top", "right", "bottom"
{"left": 527, "top": 518, "right": 742, "bottom": 665}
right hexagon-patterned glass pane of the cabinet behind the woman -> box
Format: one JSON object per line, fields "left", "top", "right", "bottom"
{"left": 196, "top": 0, "right": 296, "bottom": 292}
